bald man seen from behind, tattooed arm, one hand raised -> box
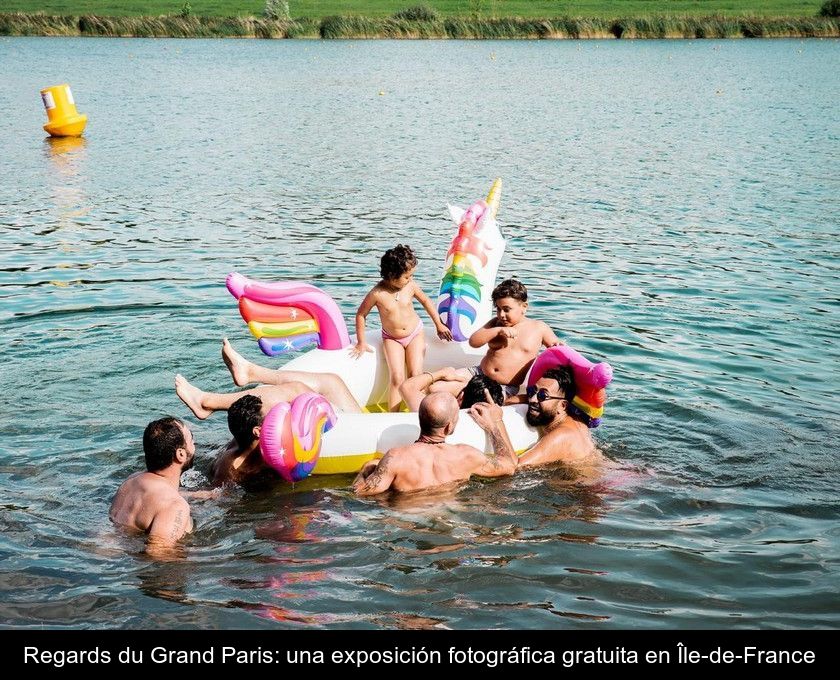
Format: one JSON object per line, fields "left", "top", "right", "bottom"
{"left": 353, "top": 392, "right": 516, "bottom": 496}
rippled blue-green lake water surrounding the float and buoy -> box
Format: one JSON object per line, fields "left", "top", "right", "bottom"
{"left": 0, "top": 38, "right": 840, "bottom": 628}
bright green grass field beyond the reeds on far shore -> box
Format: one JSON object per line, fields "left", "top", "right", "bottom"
{"left": 0, "top": 0, "right": 822, "bottom": 19}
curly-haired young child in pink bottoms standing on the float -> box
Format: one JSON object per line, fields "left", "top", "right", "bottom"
{"left": 350, "top": 245, "right": 452, "bottom": 411}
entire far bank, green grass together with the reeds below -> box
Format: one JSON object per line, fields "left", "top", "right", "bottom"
{"left": 0, "top": 0, "right": 840, "bottom": 39}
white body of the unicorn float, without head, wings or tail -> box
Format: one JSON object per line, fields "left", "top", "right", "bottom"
{"left": 283, "top": 324, "right": 537, "bottom": 475}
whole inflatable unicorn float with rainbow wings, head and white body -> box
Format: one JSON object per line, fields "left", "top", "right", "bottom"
{"left": 226, "top": 179, "right": 612, "bottom": 481}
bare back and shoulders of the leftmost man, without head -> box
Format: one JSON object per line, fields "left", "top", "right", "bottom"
{"left": 109, "top": 472, "right": 192, "bottom": 540}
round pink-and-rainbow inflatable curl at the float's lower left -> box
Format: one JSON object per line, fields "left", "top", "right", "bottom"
{"left": 260, "top": 392, "right": 336, "bottom": 482}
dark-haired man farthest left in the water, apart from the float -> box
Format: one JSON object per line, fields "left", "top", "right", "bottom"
{"left": 109, "top": 418, "right": 195, "bottom": 548}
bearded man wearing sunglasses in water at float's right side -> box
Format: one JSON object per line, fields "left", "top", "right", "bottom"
{"left": 519, "top": 366, "right": 604, "bottom": 478}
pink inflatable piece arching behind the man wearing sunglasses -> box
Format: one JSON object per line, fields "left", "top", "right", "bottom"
{"left": 527, "top": 345, "right": 612, "bottom": 427}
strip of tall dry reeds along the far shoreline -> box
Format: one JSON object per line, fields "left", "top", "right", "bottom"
{"left": 0, "top": 12, "right": 840, "bottom": 40}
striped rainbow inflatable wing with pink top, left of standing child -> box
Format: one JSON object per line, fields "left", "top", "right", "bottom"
{"left": 225, "top": 272, "right": 350, "bottom": 357}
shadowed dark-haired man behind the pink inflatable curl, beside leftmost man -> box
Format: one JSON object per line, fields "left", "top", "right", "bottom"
{"left": 210, "top": 388, "right": 281, "bottom": 491}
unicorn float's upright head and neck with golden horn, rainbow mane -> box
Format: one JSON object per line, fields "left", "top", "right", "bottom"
{"left": 438, "top": 178, "right": 505, "bottom": 342}
